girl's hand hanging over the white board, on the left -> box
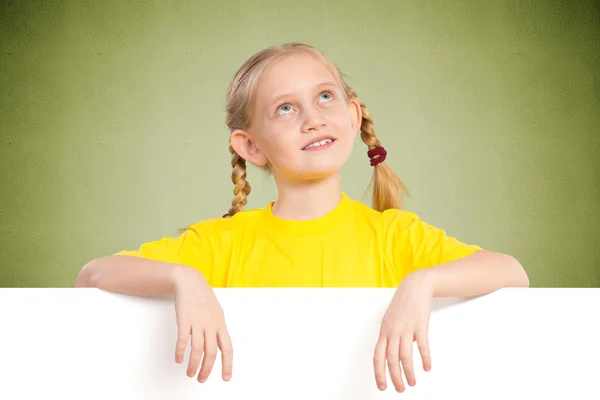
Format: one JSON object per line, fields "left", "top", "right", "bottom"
{"left": 174, "top": 267, "right": 233, "bottom": 382}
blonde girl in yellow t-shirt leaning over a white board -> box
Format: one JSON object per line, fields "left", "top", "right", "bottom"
{"left": 77, "top": 44, "right": 529, "bottom": 392}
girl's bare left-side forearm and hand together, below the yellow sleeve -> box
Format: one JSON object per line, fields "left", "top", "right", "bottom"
{"left": 75, "top": 255, "right": 233, "bottom": 382}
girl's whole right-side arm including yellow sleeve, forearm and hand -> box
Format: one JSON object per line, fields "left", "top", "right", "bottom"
{"left": 373, "top": 211, "right": 529, "bottom": 392}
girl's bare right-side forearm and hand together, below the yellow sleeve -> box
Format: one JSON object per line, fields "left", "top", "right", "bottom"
{"left": 373, "top": 250, "right": 529, "bottom": 392}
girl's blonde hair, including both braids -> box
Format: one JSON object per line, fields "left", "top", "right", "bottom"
{"left": 225, "top": 43, "right": 408, "bottom": 217}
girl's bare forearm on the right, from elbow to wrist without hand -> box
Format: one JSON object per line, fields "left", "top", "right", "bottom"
{"left": 421, "top": 251, "right": 529, "bottom": 297}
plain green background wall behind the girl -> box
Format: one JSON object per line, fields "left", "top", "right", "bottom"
{"left": 0, "top": 0, "right": 600, "bottom": 287}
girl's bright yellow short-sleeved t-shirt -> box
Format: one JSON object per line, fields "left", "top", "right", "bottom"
{"left": 117, "top": 194, "right": 481, "bottom": 288}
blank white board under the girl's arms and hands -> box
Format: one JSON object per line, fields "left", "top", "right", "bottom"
{"left": 0, "top": 289, "right": 600, "bottom": 400}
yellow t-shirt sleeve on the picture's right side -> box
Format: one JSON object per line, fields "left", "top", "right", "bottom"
{"left": 387, "top": 210, "right": 483, "bottom": 276}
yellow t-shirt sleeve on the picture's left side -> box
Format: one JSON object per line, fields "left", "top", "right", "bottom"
{"left": 115, "top": 225, "right": 220, "bottom": 281}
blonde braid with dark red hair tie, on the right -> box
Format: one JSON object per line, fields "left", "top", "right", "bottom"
{"left": 348, "top": 86, "right": 408, "bottom": 211}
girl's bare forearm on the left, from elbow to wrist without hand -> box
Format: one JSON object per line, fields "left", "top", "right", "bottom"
{"left": 75, "top": 256, "right": 195, "bottom": 296}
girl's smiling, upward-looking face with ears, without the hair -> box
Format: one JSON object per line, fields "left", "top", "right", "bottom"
{"left": 232, "top": 53, "right": 362, "bottom": 181}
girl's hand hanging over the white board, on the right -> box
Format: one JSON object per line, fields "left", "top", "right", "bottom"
{"left": 373, "top": 270, "right": 433, "bottom": 393}
